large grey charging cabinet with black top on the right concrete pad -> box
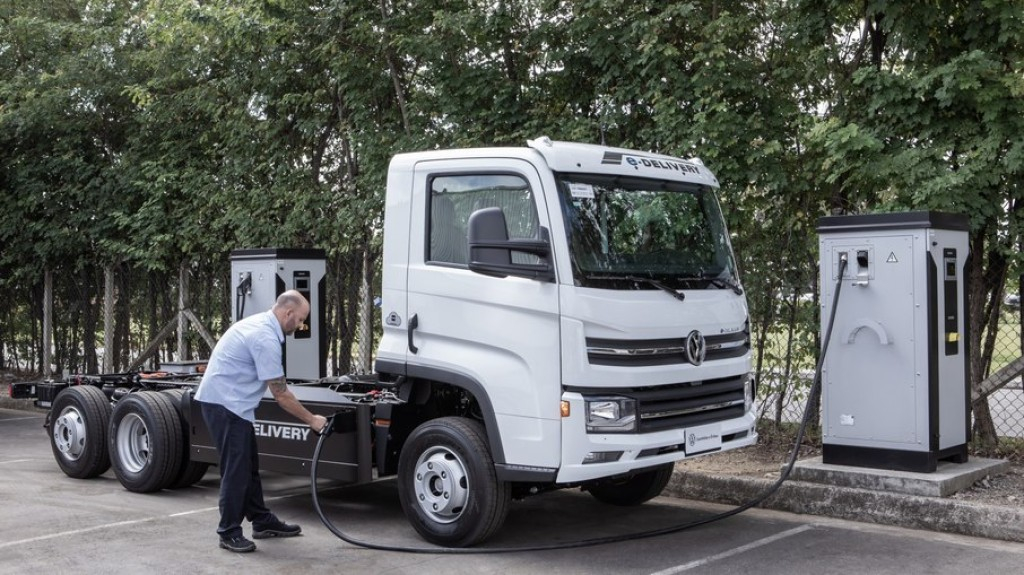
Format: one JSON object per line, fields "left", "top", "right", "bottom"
{"left": 818, "top": 212, "right": 971, "bottom": 473}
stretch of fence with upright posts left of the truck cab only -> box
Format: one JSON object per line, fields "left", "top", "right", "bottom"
{"left": 0, "top": 251, "right": 380, "bottom": 378}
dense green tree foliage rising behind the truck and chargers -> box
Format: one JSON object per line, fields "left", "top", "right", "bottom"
{"left": 0, "top": 0, "right": 1024, "bottom": 427}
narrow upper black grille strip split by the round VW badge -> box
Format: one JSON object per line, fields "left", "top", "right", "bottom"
{"left": 587, "top": 331, "right": 751, "bottom": 367}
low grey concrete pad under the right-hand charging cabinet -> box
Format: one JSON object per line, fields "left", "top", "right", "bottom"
{"left": 790, "top": 456, "right": 1010, "bottom": 497}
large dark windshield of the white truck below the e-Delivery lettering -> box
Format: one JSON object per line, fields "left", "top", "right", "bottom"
{"left": 557, "top": 169, "right": 738, "bottom": 290}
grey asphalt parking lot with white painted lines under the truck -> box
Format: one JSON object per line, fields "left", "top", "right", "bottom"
{"left": 0, "top": 408, "right": 1024, "bottom": 575}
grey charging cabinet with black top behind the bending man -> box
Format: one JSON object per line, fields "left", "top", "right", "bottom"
{"left": 231, "top": 248, "right": 327, "bottom": 380}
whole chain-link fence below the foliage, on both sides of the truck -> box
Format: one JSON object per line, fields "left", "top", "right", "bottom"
{"left": 0, "top": 246, "right": 1024, "bottom": 448}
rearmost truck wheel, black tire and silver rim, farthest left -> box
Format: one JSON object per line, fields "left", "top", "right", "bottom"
{"left": 48, "top": 386, "right": 111, "bottom": 479}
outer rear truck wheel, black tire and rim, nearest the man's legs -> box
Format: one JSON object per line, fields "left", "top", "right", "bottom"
{"left": 109, "top": 391, "right": 181, "bottom": 493}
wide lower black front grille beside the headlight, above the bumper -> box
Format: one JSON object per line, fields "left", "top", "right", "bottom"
{"left": 570, "top": 374, "right": 746, "bottom": 433}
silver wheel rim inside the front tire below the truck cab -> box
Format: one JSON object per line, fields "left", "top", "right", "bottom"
{"left": 414, "top": 447, "right": 469, "bottom": 523}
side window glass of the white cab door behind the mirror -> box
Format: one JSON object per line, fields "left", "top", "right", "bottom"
{"left": 427, "top": 174, "right": 540, "bottom": 266}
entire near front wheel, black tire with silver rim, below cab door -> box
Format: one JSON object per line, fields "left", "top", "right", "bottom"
{"left": 398, "top": 417, "right": 512, "bottom": 547}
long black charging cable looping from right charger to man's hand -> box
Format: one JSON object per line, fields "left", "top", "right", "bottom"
{"left": 309, "top": 253, "right": 848, "bottom": 555}
